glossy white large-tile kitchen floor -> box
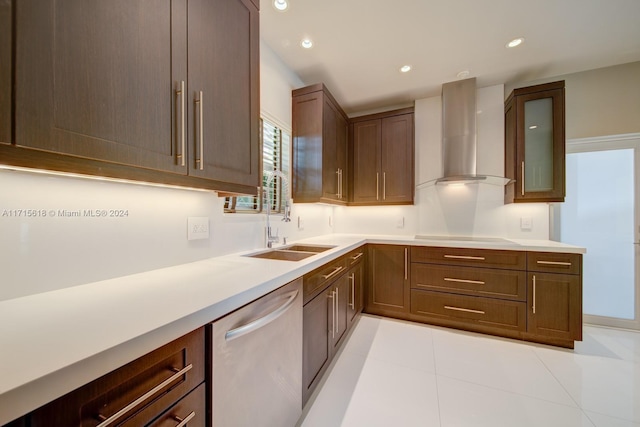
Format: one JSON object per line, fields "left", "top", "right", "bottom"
{"left": 301, "top": 315, "right": 640, "bottom": 427}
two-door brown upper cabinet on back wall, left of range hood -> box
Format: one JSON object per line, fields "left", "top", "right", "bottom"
{"left": 350, "top": 108, "right": 414, "bottom": 205}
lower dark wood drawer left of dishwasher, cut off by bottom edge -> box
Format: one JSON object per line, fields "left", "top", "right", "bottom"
{"left": 122, "top": 383, "right": 207, "bottom": 427}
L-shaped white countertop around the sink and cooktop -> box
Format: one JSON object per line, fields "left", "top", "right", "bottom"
{"left": 0, "top": 234, "right": 585, "bottom": 425}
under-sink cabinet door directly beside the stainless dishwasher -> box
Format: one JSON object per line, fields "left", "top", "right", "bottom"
{"left": 302, "top": 288, "right": 332, "bottom": 405}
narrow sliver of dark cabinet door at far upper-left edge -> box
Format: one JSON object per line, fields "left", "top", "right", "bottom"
{"left": 0, "top": 1, "right": 12, "bottom": 144}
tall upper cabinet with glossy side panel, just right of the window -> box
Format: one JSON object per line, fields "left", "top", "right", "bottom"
{"left": 292, "top": 83, "right": 348, "bottom": 204}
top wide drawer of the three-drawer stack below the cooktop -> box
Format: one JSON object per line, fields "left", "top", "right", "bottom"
{"left": 411, "top": 246, "right": 526, "bottom": 270}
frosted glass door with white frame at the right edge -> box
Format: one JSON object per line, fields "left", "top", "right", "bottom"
{"left": 554, "top": 135, "right": 640, "bottom": 329}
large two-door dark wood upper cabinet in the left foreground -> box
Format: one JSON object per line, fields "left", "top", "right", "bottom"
{"left": 15, "top": 0, "right": 261, "bottom": 193}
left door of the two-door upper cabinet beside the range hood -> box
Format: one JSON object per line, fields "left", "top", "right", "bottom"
{"left": 351, "top": 120, "right": 381, "bottom": 204}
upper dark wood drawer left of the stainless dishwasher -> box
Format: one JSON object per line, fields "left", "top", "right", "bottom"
{"left": 31, "top": 328, "right": 205, "bottom": 427}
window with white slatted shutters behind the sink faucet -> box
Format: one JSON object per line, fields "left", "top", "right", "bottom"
{"left": 224, "top": 118, "right": 291, "bottom": 213}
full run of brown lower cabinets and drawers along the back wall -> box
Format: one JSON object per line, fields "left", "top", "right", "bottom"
{"left": 364, "top": 244, "right": 582, "bottom": 348}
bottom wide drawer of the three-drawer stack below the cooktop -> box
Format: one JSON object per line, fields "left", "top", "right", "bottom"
{"left": 411, "top": 289, "right": 527, "bottom": 332}
